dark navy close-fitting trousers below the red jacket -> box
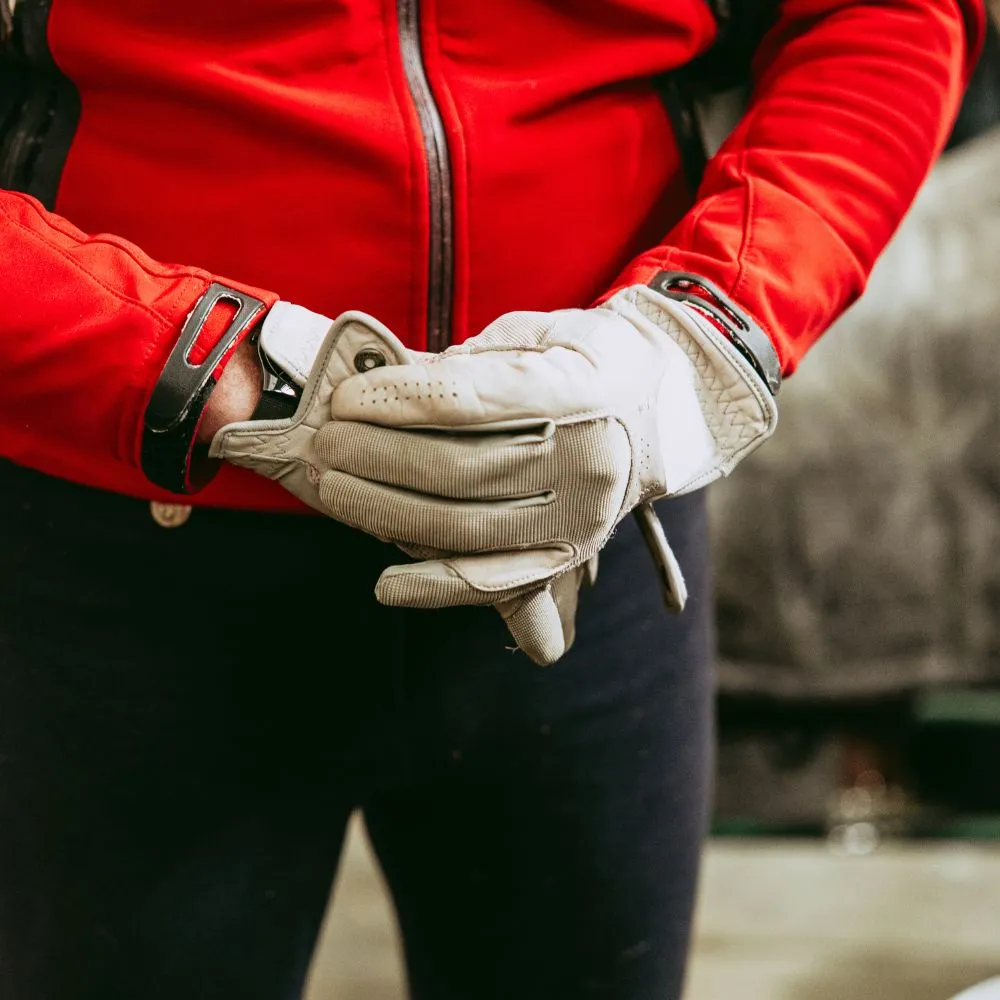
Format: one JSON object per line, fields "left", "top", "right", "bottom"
{"left": 0, "top": 466, "right": 712, "bottom": 1000}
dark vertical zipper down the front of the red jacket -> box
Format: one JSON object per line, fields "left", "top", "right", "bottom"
{"left": 398, "top": 0, "right": 455, "bottom": 351}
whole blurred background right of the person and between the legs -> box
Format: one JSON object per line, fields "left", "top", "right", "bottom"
{"left": 309, "top": 9, "right": 1000, "bottom": 1000}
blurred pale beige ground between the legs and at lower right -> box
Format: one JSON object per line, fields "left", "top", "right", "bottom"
{"left": 308, "top": 827, "right": 1000, "bottom": 1000}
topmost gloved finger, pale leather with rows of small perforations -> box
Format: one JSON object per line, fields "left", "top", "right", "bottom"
{"left": 330, "top": 349, "right": 607, "bottom": 428}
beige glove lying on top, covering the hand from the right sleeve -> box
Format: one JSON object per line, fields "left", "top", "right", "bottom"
{"left": 313, "top": 286, "right": 777, "bottom": 662}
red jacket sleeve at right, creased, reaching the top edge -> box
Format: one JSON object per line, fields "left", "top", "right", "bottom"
{"left": 604, "top": 0, "right": 985, "bottom": 372}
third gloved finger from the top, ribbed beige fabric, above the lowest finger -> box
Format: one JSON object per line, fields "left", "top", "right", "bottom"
{"left": 319, "top": 471, "right": 553, "bottom": 553}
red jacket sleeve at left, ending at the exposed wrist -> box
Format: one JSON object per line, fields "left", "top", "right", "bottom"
{"left": 0, "top": 191, "right": 276, "bottom": 491}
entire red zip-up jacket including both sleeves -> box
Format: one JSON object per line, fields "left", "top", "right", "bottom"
{"left": 0, "top": 0, "right": 984, "bottom": 508}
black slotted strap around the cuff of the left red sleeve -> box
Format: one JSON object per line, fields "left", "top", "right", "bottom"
{"left": 141, "top": 282, "right": 264, "bottom": 493}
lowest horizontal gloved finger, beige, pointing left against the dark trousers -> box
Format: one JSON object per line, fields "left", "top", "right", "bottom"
{"left": 375, "top": 545, "right": 574, "bottom": 608}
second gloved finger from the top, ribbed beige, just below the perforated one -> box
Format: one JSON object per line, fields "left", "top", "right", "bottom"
{"left": 314, "top": 421, "right": 555, "bottom": 500}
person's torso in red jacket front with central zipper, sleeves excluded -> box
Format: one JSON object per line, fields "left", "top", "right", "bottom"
{"left": 7, "top": 0, "right": 715, "bottom": 348}
